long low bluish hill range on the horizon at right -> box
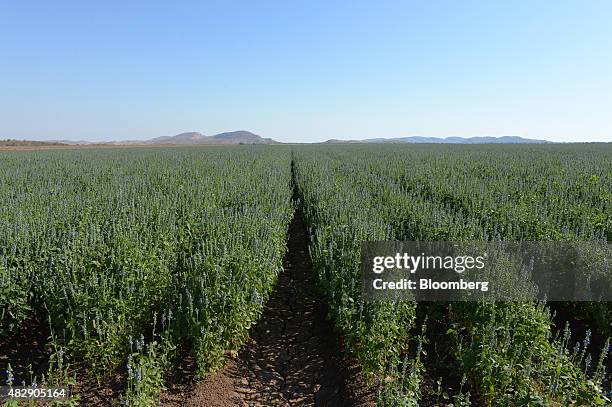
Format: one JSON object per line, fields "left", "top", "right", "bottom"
{"left": 326, "top": 136, "right": 551, "bottom": 144}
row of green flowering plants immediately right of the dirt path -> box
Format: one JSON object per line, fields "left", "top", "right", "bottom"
{"left": 293, "top": 149, "right": 424, "bottom": 406}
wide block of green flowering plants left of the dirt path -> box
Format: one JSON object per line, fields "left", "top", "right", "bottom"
{"left": 0, "top": 147, "right": 293, "bottom": 405}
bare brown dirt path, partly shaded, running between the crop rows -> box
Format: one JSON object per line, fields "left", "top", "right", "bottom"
{"left": 162, "top": 214, "right": 374, "bottom": 407}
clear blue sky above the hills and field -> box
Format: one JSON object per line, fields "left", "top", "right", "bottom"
{"left": 0, "top": 0, "right": 612, "bottom": 141}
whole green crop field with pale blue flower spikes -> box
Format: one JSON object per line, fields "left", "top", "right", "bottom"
{"left": 0, "top": 144, "right": 612, "bottom": 407}
